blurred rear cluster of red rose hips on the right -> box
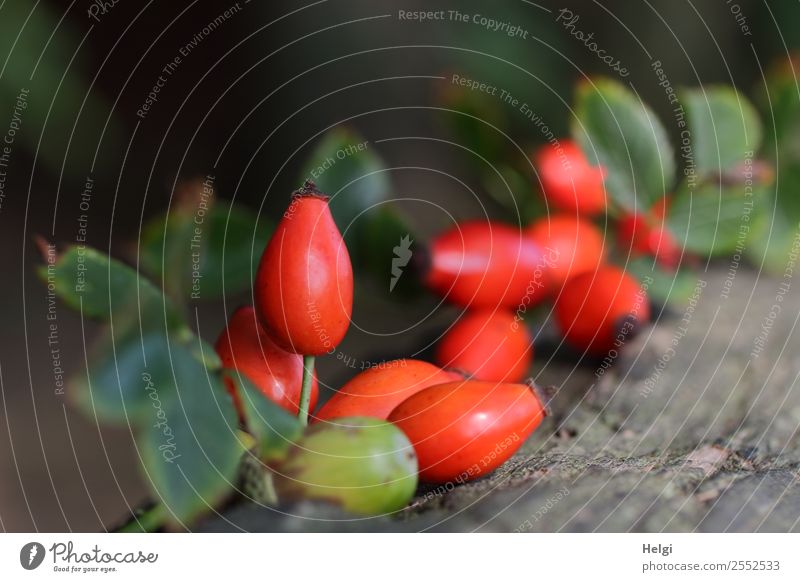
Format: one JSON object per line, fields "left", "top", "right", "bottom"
{"left": 427, "top": 141, "right": 664, "bottom": 382}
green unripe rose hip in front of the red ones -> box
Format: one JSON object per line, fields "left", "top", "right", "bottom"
{"left": 273, "top": 417, "right": 417, "bottom": 515}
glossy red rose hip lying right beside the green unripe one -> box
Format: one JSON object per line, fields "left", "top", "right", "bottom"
{"left": 389, "top": 381, "right": 545, "bottom": 483}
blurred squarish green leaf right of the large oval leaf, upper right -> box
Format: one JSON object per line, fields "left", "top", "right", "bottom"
{"left": 680, "top": 86, "right": 763, "bottom": 179}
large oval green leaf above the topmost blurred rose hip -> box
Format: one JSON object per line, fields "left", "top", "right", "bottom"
{"left": 572, "top": 78, "right": 675, "bottom": 210}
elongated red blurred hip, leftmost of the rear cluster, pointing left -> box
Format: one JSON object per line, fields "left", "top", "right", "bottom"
{"left": 426, "top": 220, "right": 544, "bottom": 309}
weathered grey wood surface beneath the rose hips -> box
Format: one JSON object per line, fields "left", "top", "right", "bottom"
{"left": 205, "top": 265, "right": 800, "bottom": 532}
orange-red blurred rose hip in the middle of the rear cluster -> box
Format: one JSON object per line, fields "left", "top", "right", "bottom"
{"left": 527, "top": 214, "right": 606, "bottom": 295}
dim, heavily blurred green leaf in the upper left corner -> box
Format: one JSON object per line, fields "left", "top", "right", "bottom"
{"left": 0, "top": 0, "right": 128, "bottom": 179}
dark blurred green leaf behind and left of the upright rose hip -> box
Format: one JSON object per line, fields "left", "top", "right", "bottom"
{"left": 140, "top": 200, "right": 274, "bottom": 299}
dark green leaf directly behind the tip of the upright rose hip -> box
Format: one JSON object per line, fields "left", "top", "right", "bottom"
{"left": 301, "top": 127, "right": 392, "bottom": 237}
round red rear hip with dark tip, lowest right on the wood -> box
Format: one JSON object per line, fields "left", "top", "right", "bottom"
{"left": 555, "top": 266, "right": 650, "bottom": 356}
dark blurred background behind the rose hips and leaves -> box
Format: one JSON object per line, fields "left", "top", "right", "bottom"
{"left": 0, "top": 0, "right": 800, "bottom": 531}
